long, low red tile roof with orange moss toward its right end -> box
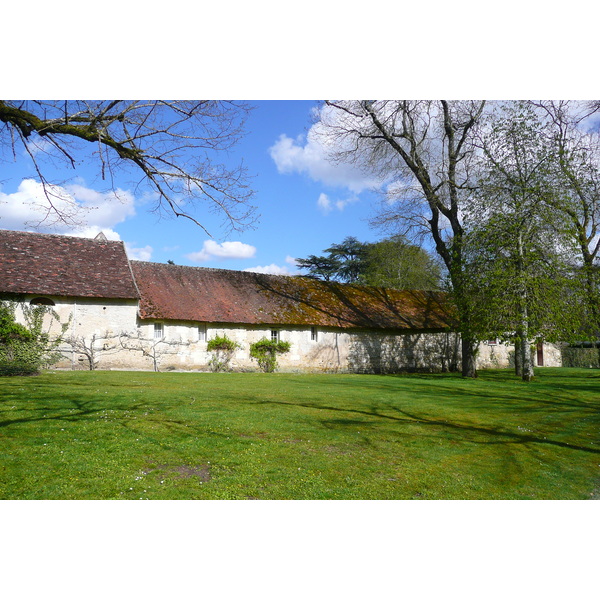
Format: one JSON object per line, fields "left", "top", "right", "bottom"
{"left": 131, "top": 261, "right": 450, "bottom": 331}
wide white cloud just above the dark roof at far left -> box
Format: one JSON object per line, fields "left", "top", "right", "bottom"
{"left": 0, "top": 179, "right": 135, "bottom": 239}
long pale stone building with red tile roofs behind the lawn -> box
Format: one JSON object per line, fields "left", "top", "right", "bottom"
{"left": 0, "top": 230, "right": 560, "bottom": 373}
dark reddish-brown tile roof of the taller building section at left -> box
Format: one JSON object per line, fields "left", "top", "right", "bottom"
{"left": 0, "top": 230, "right": 138, "bottom": 299}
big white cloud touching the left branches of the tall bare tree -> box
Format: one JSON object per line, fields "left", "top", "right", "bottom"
{"left": 269, "top": 132, "right": 380, "bottom": 194}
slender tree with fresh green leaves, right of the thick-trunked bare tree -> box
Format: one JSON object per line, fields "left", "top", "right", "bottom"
{"left": 465, "top": 102, "right": 575, "bottom": 381}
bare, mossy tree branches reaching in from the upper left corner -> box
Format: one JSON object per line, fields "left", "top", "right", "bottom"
{"left": 0, "top": 100, "right": 255, "bottom": 233}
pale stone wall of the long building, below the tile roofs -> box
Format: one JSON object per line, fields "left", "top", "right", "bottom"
{"left": 9, "top": 296, "right": 561, "bottom": 373}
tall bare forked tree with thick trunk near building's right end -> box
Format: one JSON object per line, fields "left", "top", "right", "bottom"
{"left": 320, "top": 100, "right": 485, "bottom": 377}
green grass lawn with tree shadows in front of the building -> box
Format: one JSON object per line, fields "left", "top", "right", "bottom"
{"left": 0, "top": 369, "right": 600, "bottom": 500}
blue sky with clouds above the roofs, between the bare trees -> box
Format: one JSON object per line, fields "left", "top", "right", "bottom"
{"left": 0, "top": 100, "right": 390, "bottom": 274}
